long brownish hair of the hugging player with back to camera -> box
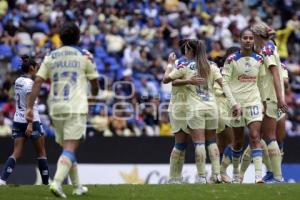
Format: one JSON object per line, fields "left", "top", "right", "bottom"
{"left": 186, "top": 39, "right": 210, "bottom": 79}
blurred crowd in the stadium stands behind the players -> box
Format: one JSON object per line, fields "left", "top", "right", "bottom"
{"left": 0, "top": 0, "right": 300, "bottom": 136}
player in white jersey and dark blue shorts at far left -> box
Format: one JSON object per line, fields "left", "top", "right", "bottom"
{"left": 0, "top": 56, "right": 49, "bottom": 185}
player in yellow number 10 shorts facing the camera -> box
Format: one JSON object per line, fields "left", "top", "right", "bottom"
{"left": 223, "top": 29, "right": 265, "bottom": 183}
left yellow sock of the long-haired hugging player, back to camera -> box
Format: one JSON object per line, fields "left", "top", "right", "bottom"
{"left": 194, "top": 142, "right": 206, "bottom": 176}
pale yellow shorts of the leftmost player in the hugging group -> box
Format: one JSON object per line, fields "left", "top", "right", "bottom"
{"left": 169, "top": 111, "right": 190, "bottom": 134}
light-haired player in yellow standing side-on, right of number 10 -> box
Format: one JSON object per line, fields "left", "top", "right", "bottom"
{"left": 251, "top": 22, "right": 288, "bottom": 183}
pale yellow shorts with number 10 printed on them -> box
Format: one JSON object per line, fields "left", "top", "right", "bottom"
{"left": 230, "top": 104, "right": 263, "bottom": 127}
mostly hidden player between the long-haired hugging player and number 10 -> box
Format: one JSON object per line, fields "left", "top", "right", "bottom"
{"left": 214, "top": 47, "right": 240, "bottom": 183}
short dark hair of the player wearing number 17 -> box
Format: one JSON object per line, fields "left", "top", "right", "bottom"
{"left": 59, "top": 22, "right": 80, "bottom": 45}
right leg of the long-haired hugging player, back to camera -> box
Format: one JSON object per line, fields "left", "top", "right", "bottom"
{"left": 205, "top": 130, "right": 222, "bottom": 183}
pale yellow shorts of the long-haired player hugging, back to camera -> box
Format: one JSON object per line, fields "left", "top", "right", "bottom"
{"left": 187, "top": 109, "right": 219, "bottom": 130}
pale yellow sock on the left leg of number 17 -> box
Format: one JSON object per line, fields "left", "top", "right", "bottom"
{"left": 54, "top": 155, "right": 72, "bottom": 185}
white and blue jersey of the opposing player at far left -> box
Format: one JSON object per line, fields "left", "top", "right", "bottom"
{"left": 14, "top": 76, "right": 40, "bottom": 123}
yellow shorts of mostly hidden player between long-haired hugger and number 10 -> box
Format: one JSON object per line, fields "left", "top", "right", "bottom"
{"left": 216, "top": 97, "right": 231, "bottom": 133}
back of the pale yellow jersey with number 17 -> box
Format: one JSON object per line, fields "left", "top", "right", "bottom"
{"left": 37, "top": 46, "right": 97, "bottom": 115}
